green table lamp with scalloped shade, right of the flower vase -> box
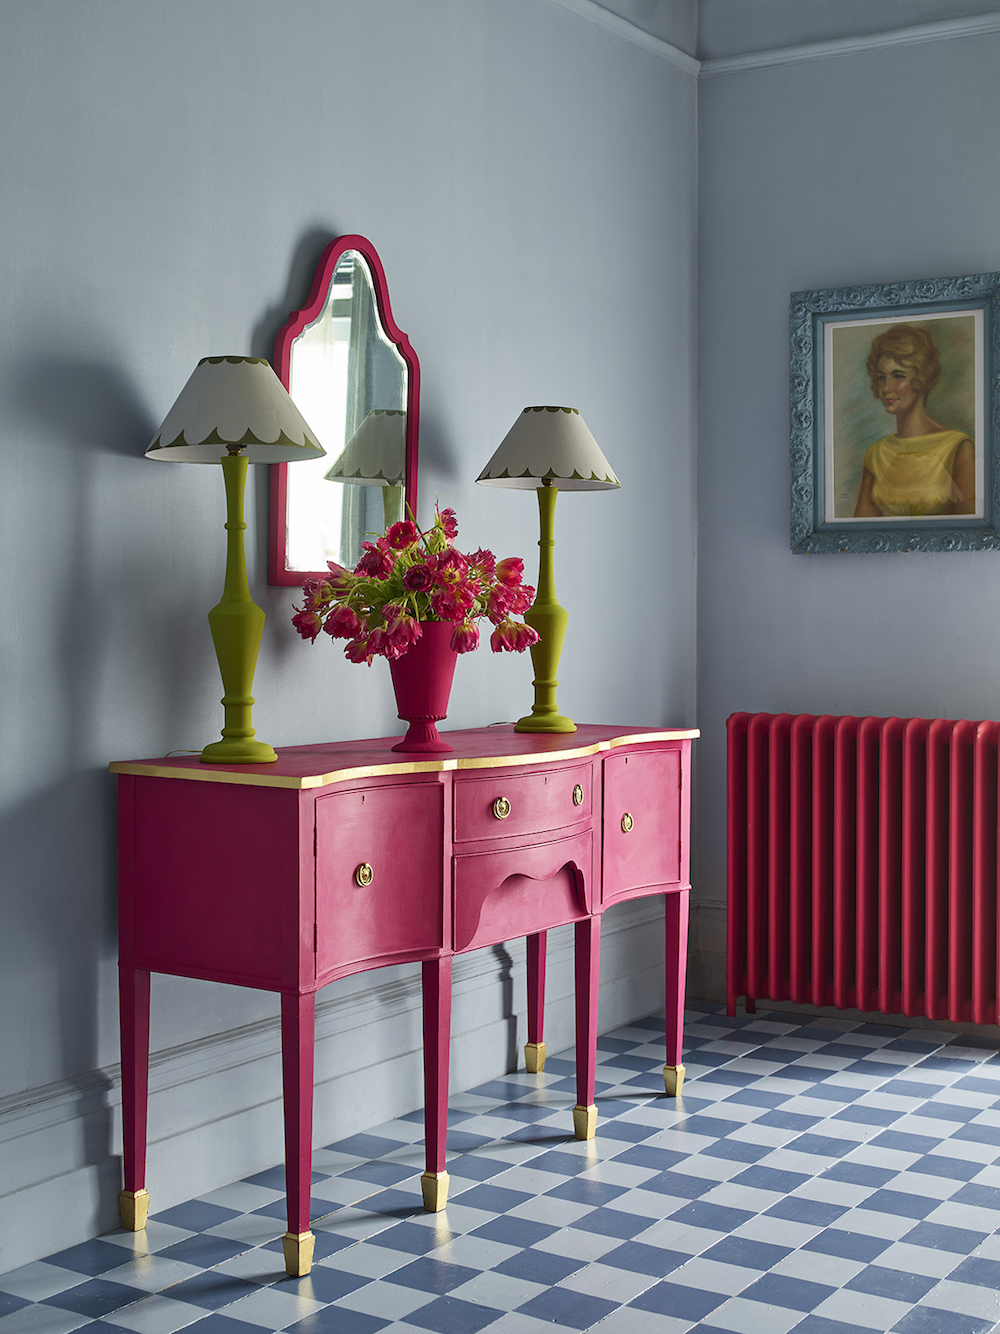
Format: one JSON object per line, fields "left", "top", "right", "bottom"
{"left": 476, "top": 407, "right": 621, "bottom": 732}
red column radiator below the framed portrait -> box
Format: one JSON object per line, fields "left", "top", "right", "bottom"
{"left": 727, "top": 714, "right": 1000, "bottom": 1023}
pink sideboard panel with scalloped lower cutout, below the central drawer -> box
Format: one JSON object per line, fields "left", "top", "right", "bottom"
{"left": 453, "top": 830, "right": 593, "bottom": 951}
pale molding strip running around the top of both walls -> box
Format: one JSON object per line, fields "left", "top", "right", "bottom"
{"left": 549, "top": 0, "right": 1000, "bottom": 79}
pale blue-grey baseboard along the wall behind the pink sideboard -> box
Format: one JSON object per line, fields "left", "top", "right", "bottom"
{"left": 0, "top": 899, "right": 674, "bottom": 1273}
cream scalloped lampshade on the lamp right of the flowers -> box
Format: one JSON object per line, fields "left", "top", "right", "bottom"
{"left": 476, "top": 407, "right": 621, "bottom": 491}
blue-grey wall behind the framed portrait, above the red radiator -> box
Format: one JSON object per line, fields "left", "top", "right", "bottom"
{"left": 697, "top": 18, "right": 1000, "bottom": 994}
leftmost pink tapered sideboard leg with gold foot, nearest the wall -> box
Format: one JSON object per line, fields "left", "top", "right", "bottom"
{"left": 119, "top": 967, "right": 149, "bottom": 1233}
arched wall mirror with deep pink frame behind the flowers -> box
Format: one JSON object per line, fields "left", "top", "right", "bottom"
{"left": 268, "top": 236, "right": 420, "bottom": 584}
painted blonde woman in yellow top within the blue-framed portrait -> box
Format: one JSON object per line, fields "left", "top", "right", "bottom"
{"left": 855, "top": 324, "right": 976, "bottom": 519}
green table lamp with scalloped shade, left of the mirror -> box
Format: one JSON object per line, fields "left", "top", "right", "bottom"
{"left": 145, "top": 356, "right": 325, "bottom": 764}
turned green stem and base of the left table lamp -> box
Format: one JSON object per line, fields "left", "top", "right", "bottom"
{"left": 201, "top": 454, "right": 277, "bottom": 764}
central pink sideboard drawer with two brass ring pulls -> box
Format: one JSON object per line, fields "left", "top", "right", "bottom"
{"left": 455, "top": 764, "right": 593, "bottom": 843}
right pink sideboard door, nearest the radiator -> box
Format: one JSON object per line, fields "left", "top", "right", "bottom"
{"left": 603, "top": 750, "right": 681, "bottom": 903}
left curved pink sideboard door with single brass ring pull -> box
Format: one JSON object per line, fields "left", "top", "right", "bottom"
{"left": 316, "top": 783, "right": 444, "bottom": 978}
